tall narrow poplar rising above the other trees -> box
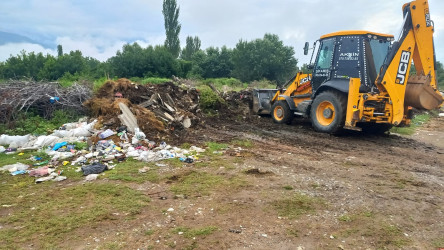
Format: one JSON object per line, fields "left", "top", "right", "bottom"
{"left": 162, "top": 0, "right": 181, "bottom": 58}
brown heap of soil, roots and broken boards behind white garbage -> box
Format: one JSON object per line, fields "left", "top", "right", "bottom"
{"left": 84, "top": 78, "right": 202, "bottom": 140}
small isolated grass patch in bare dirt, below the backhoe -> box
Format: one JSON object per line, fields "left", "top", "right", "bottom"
{"left": 271, "top": 193, "right": 324, "bottom": 219}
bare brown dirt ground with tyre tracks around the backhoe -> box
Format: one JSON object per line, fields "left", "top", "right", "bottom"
{"left": 0, "top": 112, "right": 444, "bottom": 249}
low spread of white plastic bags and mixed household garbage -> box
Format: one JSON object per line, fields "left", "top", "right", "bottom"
{"left": 0, "top": 118, "right": 205, "bottom": 183}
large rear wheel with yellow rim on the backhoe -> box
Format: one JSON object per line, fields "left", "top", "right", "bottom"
{"left": 310, "top": 91, "right": 347, "bottom": 134}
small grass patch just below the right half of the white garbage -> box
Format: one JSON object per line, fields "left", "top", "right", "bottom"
{"left": 105, "top": 158, "right": 160, "bottom": 183}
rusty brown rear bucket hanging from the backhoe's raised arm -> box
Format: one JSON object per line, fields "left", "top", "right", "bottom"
{"left": 404, "top": 75, "right": 444, "bottom": 110}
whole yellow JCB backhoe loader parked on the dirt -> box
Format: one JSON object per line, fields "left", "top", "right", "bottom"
{"left": 253, "top": 0, "right": 443, "bottom": 133}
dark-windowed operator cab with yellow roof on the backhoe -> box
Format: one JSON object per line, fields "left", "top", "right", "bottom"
{"left": 311, "top": 31, "right": 394, "bottom": 93}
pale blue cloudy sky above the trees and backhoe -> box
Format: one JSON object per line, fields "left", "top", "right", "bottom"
{"left": 0, "top": 0, "right": 444, "bottom": 63}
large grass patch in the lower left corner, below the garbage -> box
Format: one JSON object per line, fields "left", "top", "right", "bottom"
{"left": 0, "top": 182, "right": 149, "bottom": 248}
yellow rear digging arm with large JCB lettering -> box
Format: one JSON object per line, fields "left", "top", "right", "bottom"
{"left": 376, "top": 0, "right": 442, "bottom": 125}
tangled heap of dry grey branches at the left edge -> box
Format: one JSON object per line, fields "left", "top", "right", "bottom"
{"left": 0, "top": 81, "right": 92, "bottom": 123}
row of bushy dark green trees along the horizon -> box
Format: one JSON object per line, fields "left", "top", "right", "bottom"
{"left": 0, "top": 34, "right": 297, "bottom": 84}
